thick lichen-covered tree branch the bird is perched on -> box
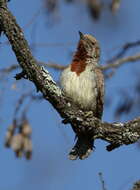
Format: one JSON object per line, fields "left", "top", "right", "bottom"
{"left": 0, "top": 0, "right": 140, "bottom": 156}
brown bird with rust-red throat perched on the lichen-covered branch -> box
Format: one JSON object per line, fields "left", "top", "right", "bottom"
{"left": 60, "top": 31, "right": 104, "bottom": 160}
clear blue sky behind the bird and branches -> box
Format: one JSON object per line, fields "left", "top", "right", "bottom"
{"left": 0, "top": 0, "right": 140, "bottom": 190}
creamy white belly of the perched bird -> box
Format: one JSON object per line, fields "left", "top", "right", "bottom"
{"left": 60, "top": 67, "right": 97, "bottom": 110}
